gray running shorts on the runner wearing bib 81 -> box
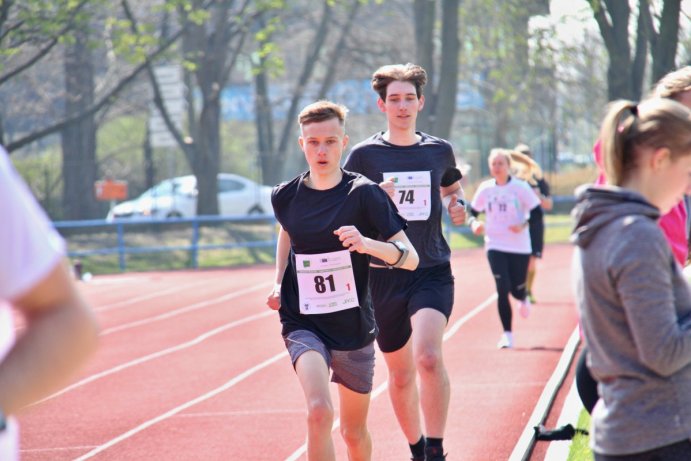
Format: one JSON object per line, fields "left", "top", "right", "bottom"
{"left": 283, "top": 330, "right": 374, "bottom": 394}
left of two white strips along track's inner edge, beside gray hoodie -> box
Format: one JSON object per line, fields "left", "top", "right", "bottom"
{"left": 509, "top": 327, "right": 581, "bottom": 461}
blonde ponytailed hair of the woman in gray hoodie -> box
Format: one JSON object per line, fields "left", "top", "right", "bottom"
{"left": 600, "top": 98, "right": 691, "bottom": 186}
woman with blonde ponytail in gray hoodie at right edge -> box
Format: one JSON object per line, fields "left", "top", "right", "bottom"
{"left": 572, "top": 99, "right": 691, "bottom": 461}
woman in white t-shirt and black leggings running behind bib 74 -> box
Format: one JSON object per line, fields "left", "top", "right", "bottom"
{"left": 468, "top": 149, "right": 540, "bottom": 349}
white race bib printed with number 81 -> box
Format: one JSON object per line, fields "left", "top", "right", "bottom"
{"left": 295, "top": 250, "right": 360, "bottom": 315}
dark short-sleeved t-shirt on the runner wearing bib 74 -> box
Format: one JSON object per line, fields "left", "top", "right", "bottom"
{"left": 343, "top": 132, "right": 460, "bottom": 268}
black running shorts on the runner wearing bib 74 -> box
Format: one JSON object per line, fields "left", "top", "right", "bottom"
{"left": 370, "top": 262, "right": 454, "bottom": 352}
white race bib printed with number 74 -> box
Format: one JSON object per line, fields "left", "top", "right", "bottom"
{"left": 384, "top": 171, "right": 432, "bottom": 221}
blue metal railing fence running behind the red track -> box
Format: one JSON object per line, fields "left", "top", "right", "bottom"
{"left": 54, "top": 197, "right": 574, "bottom": 273}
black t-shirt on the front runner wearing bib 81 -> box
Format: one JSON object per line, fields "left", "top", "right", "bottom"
{"left": 271, "top": 171, "right": 406, "bottom": 350}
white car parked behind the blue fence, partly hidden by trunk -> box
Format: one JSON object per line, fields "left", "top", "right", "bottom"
{"left": 106, "top": 173, "right": 273, "bottom": 220}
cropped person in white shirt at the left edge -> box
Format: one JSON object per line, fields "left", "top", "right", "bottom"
{"left": 0, "top": 147, "right": 98, "bottom": 461}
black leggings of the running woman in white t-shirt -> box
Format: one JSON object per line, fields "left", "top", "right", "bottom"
{"left": 487, "top": 250, "right": 530, "bottom": 331}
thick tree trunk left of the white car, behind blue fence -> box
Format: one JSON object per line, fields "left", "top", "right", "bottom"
{"left": 61, "top": 31, "right": 99, "bottom": 219}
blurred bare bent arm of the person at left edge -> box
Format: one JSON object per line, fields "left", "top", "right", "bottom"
{"left": 0, "top": 262, "right": 98, "bottom": 415}
